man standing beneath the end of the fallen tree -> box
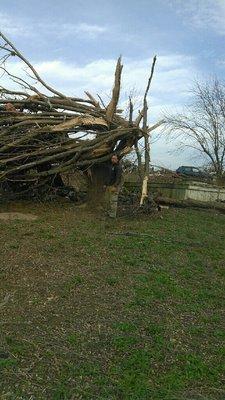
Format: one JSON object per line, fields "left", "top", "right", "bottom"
{"left": 105, "top": 154, "right": 122, "bottom": 218}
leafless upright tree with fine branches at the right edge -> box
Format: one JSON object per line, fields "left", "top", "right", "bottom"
{"left": 164, "top": 79, "right": 225, "bottom": 177}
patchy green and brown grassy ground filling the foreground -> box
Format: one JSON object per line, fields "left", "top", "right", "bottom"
{"left": 0, "top": 204, "right": 225, "bottom": 400}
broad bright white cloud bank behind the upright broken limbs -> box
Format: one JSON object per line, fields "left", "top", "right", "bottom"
{"left": 2, "top": 54, "right": 197, "bottom": 115}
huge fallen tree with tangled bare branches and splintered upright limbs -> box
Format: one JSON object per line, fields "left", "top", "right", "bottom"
{"left": 0, "top": 33, "right": 158, "bottom": 202}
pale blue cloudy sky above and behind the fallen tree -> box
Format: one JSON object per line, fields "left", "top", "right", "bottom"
{"left": 0, "top": 0, "right": 225, "bottom": 168}
